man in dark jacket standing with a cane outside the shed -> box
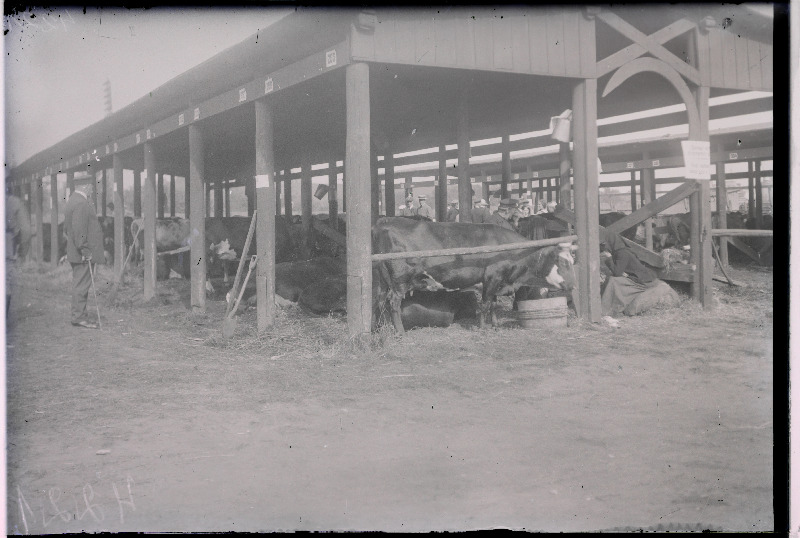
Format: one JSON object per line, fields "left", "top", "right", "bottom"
{"left": 64, "top": 176, "right": 105, "bottom": 329}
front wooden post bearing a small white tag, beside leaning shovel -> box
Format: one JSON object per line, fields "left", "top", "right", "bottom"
{"left": 255, "top": 98, "right": 282, "bottom": 333}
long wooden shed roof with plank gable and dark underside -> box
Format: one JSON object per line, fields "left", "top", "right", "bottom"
{"left": 4, "top": 5, "right": 772, "bottom": 186}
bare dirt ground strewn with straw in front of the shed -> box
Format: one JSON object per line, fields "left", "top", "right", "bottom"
{"left": 6, "top": 260, "right": 782, "bottom": 534}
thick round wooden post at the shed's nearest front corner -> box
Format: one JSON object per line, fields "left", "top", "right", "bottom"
{"left": 345, "top": 63, "right": 372, "bottom": 338}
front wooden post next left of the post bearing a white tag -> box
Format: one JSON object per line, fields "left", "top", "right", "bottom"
{"left": 187, "top": 124, "right": 208, "bottom": 312}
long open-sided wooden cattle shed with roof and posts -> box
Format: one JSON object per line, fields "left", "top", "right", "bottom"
{"left": 6, "top": 4, "right": 773, "bottom": 335}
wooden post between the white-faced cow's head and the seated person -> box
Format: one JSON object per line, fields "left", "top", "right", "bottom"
{"left": 572, "top": 79, "right": 602, "bottom": 322}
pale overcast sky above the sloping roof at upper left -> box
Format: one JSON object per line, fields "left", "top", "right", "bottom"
{"left": 3, "top": 8, "right": 289, "bottom": 165}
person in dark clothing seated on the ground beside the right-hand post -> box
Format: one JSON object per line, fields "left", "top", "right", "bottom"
{"left": 600, "top": 230, "right": 679, "bottom": 316}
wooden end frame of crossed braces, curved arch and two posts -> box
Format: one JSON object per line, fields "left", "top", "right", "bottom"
{"left": 573, "top": 7, "right": 713, "bottom": 314}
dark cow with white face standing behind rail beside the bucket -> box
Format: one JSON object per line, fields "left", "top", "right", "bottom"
{"left": 372, "top": 217, "right": 574, "bottom": 332}
